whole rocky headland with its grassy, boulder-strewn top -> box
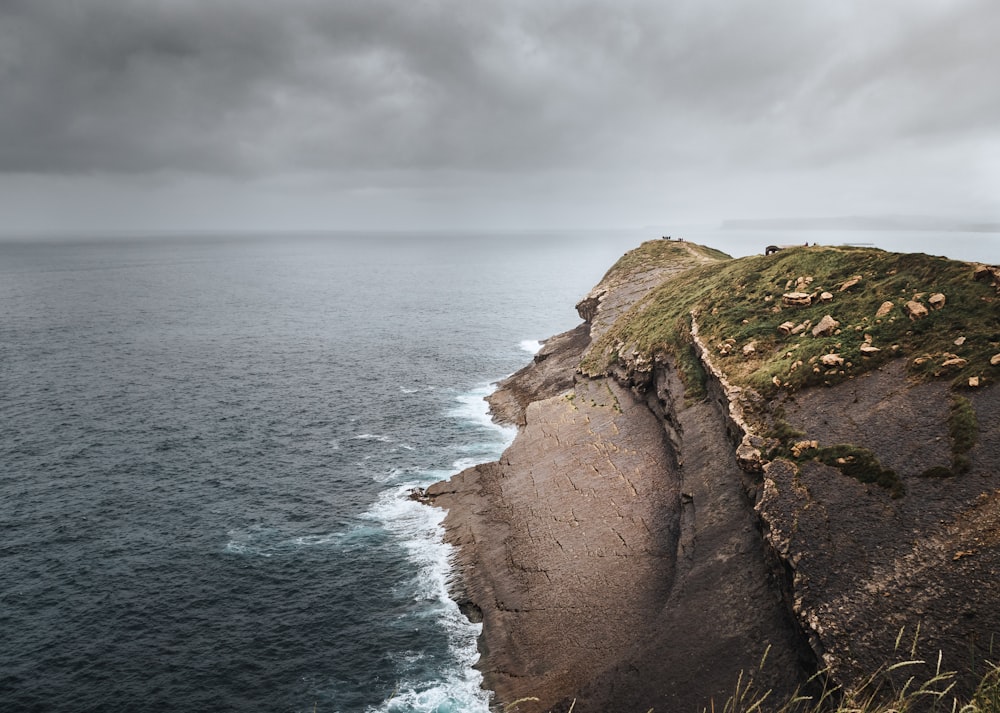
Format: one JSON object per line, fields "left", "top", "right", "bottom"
{"left": 427, "top": 241, "right": 1000, "bottom": 713}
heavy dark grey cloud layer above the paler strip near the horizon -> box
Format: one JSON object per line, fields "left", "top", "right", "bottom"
{"left": 0, "top": 0, "right": 1000, "bottom": 225}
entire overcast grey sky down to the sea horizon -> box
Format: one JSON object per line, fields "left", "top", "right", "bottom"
{"left": 0, "top": 0, "right": 1000, "bottom": 231}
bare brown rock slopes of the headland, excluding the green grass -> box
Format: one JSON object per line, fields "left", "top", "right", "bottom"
{"left": 425, "top": 241, "right": 1000, "bottom": 713}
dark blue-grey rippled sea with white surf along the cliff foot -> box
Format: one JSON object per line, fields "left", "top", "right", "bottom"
{"left": 0, "top": 230, "right": 1000, "bottom": 713}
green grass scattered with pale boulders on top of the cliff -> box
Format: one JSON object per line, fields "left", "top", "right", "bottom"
{"left": 581, "top": 241, "right": 1000, "bottom": 397}
